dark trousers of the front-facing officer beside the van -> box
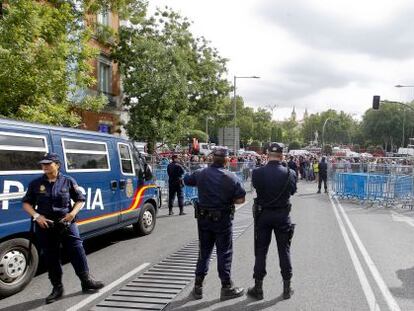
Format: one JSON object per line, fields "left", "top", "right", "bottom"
{"left": 36, "top": 223, "right": 89, "bottom": 286}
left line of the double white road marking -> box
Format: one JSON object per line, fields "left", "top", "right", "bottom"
{"left": 329, "top": 196, "right": 381, "bottom": 311}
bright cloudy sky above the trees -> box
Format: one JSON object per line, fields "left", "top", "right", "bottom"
{"left": 149, "top": 0, "right": 414, "bottom": 120}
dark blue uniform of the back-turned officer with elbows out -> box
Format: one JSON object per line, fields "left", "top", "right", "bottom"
{"left": 184, "top": 164, "right": 246, "bottom": 284}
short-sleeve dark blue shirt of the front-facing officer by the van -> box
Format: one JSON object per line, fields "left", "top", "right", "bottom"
{"left": 22, "top": 173, "right": 85, "bottom": 218}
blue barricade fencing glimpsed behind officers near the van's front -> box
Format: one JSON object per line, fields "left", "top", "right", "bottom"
{"left": 153, "top": 162, "right": 254, "bottom": 204}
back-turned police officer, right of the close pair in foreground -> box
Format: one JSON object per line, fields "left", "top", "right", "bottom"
{"left": 247, "top": 143, "right": 296, "bottom": 300}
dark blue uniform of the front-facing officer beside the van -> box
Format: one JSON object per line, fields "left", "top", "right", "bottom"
{"left": 23, "top": 173, "right": 89, "bottom": 286}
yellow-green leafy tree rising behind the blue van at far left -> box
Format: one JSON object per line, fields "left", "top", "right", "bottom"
{"left": 0, "top": 0, "right": 137, "bottom": 126}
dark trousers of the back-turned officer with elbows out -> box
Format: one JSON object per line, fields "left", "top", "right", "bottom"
{"left": 195, "top": 216, "right": 233, "bottom": 283}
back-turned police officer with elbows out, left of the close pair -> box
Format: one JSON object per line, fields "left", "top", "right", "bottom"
{"left": 184, "top": 148, "right": 246, "bottom": 300}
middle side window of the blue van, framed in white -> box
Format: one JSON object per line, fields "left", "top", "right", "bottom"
{"left": 62, "top": 138, "right": 110, "bottom": 172}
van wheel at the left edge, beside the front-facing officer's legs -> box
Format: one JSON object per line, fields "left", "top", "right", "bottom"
{"left": 0, "top": 238, "right": 39, "bottom": 297}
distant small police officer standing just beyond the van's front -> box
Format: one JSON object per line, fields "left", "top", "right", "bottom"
{"left": 167, "top": 154, "right": 185, "bottom": 215}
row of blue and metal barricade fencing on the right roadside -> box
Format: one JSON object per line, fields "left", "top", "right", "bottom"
{"left": 329, "top": 163, "right": 414, "bottom": 209}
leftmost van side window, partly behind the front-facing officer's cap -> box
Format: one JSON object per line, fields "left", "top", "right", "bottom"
{"left": 0, "top": 132, "right": 48, "bottom": 173}
